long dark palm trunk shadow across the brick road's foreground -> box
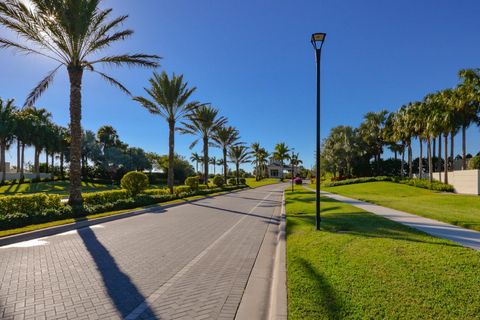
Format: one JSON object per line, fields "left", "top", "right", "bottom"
{"left": 78, "top": 227, "right": 156, "bottom": 319}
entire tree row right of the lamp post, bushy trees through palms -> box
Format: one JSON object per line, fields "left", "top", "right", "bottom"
{"left": 322, "top": 69, "right": 480, "bottom": 183}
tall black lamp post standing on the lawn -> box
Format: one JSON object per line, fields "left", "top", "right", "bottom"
{"left": 310, "top": 33, "right": 327, "bottom": 230}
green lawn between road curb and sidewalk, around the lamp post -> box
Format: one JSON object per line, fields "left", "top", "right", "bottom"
{"left": 286, "top": 188, "right": 480, "bottom": 319}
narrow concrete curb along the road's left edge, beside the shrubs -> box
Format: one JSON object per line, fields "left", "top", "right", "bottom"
{"left": 0, "top": 188, "right": 247, "bottom": 247}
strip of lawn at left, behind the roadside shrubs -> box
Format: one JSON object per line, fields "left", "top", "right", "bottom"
{"left": 0, "top": 181, "right": 118, "bottom": 195}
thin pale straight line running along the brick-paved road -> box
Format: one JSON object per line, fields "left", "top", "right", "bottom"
{"left": 124, "top": 191, "right": 275, "bottom": 320}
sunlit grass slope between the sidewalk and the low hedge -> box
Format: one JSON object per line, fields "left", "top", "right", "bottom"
{"left": 322, "top": 182, "right": 480, "bottom": 231}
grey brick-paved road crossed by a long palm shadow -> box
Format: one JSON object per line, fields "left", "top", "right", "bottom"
{"left": 0, "top": 185, "right": 283, "bottom": 319}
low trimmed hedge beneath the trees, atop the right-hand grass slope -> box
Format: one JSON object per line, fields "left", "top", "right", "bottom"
{"left": 325, "top": 176, "right": 455, "bottom": 192}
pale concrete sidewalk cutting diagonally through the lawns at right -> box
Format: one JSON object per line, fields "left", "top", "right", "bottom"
{"left": 304, "top": 186, "right": 480, "bottom": 250}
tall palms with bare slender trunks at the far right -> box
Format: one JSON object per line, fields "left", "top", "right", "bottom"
{"left": 385, "top": 69, "right": 480, "bottom": 183}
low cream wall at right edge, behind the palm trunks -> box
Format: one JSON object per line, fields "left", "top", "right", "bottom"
{"left": 433, "top": 170, "right": 480, "bottom": 195}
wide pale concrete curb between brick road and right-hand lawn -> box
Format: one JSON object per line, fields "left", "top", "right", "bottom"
{"left": 235, "top": 186, "right": 287, "bottom": 320}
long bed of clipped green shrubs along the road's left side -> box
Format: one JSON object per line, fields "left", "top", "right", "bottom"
{"left": 0, "top": 185, "right": 246, "bottom": 230}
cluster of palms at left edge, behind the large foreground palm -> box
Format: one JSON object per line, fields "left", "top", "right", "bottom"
{"left": 0, "top": 98, "right": 69, "bottom": 181}
